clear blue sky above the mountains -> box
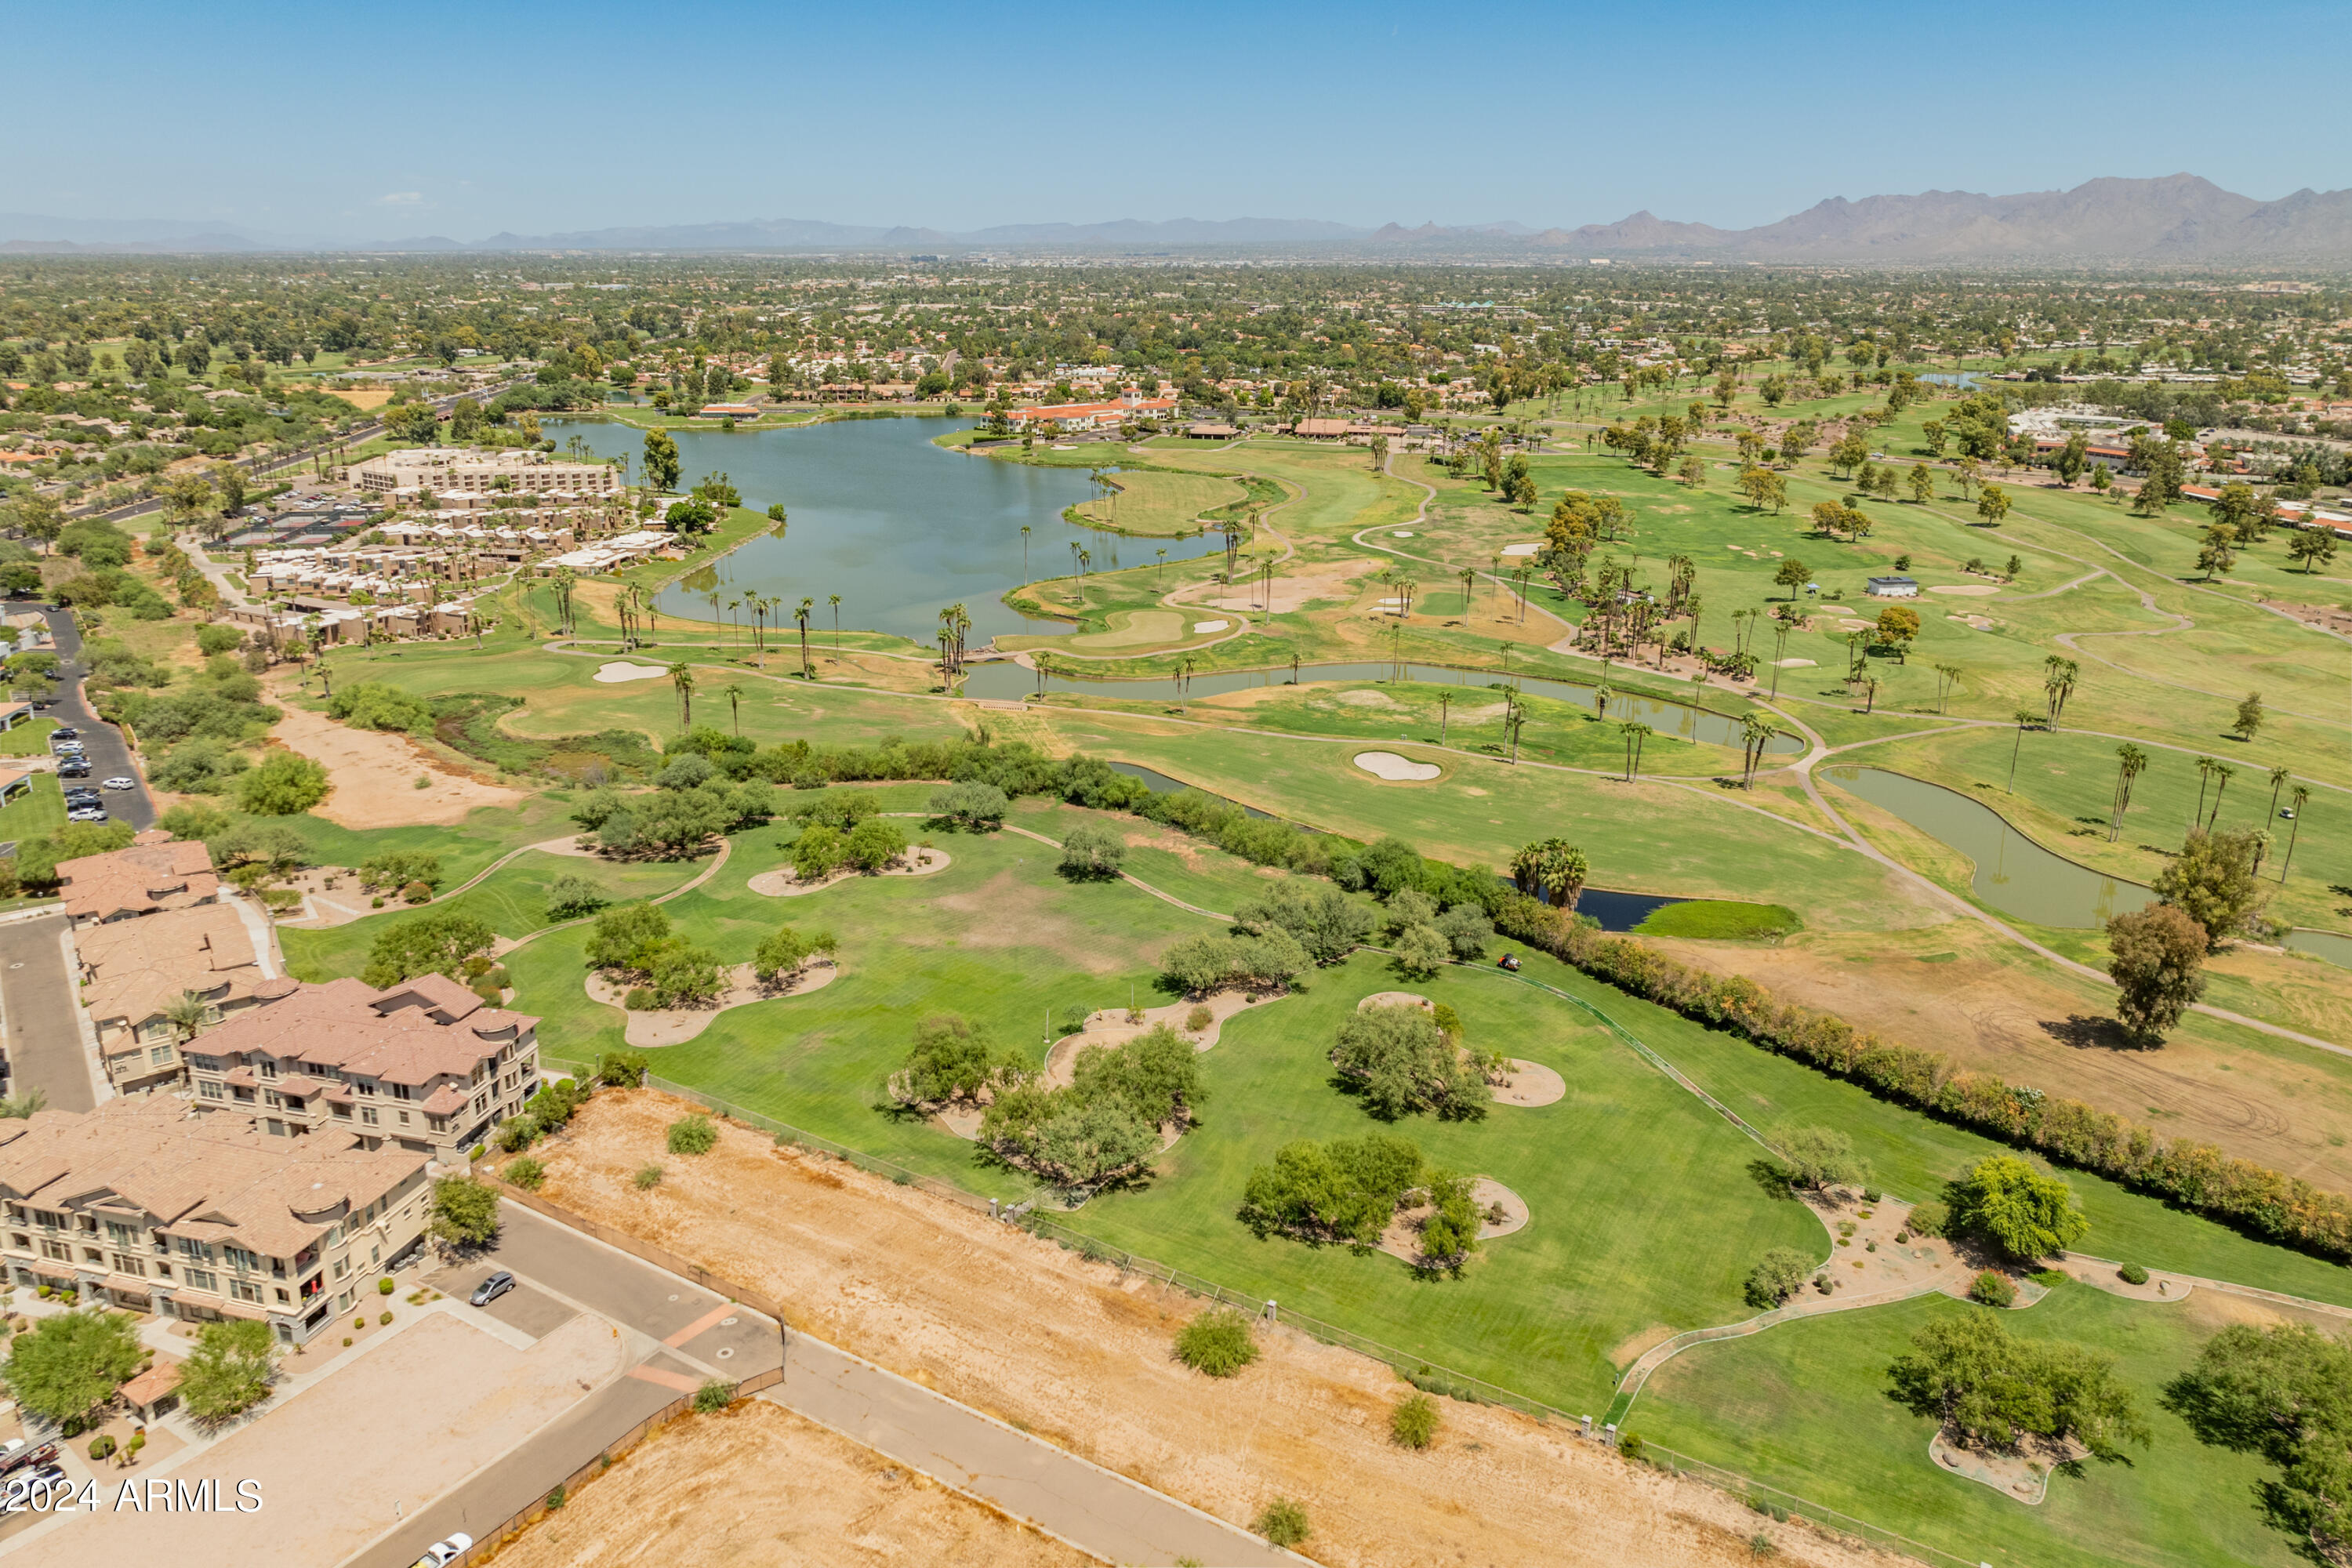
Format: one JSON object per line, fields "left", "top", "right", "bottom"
{"left": 23, "top": 0, "right": 2352, "bottom": 240}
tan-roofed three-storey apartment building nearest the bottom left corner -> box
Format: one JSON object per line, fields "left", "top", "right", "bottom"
{"left": 0, "top": 1095, "right": 430, "bottom": 1345}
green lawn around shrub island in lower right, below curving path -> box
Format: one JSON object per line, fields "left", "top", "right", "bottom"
{"left": 1625, "top": 1283, "right": 2303, "bottom": 1568}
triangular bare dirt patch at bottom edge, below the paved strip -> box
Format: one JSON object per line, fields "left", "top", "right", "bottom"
{"left": 496, "top": 1399, "right": 1098, "bottom": 1568}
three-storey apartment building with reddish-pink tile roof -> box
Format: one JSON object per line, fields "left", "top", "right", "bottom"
{"left": 186, "top": 975, "right": 539, "bottom": 1163}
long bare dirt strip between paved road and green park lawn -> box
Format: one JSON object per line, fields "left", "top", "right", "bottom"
{"left": 520, "top": 1091, "right": 1893, "bottom": 1568}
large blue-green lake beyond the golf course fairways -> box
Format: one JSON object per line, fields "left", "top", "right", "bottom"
{"left": 546, "top": 419, "right": 1225, "bottom": 644}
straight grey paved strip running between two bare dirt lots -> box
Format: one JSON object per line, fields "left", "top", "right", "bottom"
{"left": 760, "top": 1333, "right": 1305, "bottom": 1568}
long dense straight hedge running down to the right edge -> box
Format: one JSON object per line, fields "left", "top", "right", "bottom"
{"left": 1494, "top": 898, "right": 2352, "bottom": 1262}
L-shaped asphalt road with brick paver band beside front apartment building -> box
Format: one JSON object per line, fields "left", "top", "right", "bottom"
{"left": 346, "top": 1203, "right": 783, "bottom": 1568}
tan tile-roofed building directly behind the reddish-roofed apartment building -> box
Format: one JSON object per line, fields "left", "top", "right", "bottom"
{"left": 73, "top": 902, "right": 294, "bottom": 1093}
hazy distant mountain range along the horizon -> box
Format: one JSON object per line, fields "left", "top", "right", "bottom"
{"left": 13, "top": 174, "right": 2352, "bottom": 266}
